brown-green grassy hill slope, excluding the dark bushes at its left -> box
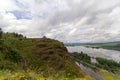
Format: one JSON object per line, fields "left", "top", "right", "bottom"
{"left": 1, "top": 34, "right": 90, "bottom": 77}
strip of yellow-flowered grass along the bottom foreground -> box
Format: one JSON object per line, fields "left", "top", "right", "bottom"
{"left": 0, "top": 70, "right": 93, "bottom": 80}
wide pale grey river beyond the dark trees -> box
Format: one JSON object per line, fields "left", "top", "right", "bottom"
{"left": 67, "top": 46, "right": 120, "bottom": 62}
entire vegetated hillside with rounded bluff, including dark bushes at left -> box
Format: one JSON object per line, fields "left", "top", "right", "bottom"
{"left": 0, "top": 30, "right": 88, "bottom": 78}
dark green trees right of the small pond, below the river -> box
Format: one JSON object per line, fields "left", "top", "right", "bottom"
{"left": 96, "top": 57, "right": 120, "bottom": 73}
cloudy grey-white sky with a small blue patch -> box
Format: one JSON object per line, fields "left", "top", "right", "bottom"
{"left": 0, "top": 0, "right": 120, "bottom": 42}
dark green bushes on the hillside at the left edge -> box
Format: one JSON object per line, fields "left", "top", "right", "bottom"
{"left": 0, "top": 34, "right": 22, "bottom": 70}
